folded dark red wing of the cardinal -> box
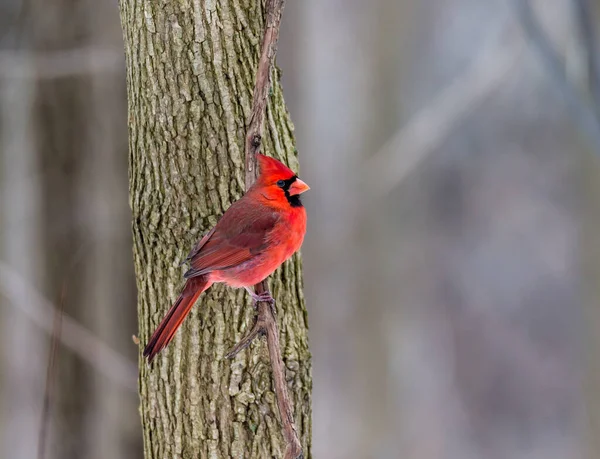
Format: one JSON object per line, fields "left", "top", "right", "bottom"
{"left": 185, "top": 200, "right": 279, "bottom": 278}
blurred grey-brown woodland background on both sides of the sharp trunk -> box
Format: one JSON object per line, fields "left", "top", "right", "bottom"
{"left": 0, "top": 0, "right": 600, "bottom": 459}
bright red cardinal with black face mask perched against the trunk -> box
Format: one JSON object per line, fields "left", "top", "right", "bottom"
{"left": 144, "top": 154, "right": 309, "bottom": 362}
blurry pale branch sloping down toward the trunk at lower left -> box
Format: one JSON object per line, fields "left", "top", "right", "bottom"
{"left": 0, "top": 261, "right": 137, "bottom": 393}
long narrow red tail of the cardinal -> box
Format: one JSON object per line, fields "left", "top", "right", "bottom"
{"left": 144, "top": 276, "right": 212, "bottom": 362}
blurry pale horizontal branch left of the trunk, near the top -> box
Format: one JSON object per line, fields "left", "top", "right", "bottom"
{"left": 0, "top": 48, "right": 122, "bottom": 80}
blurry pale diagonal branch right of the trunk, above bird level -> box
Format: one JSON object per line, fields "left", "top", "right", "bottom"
{"left": 363, "top": 24, "right": 521, "bottom": 199}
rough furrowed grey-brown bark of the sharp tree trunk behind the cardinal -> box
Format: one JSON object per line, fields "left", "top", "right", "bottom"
{"left": 120, "top": 0, "right": 312, "bottom": 459}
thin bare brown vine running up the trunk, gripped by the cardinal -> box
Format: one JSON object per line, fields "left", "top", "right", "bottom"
{"left": 228, "top": 0, "right": 302, "bottom": 459}
